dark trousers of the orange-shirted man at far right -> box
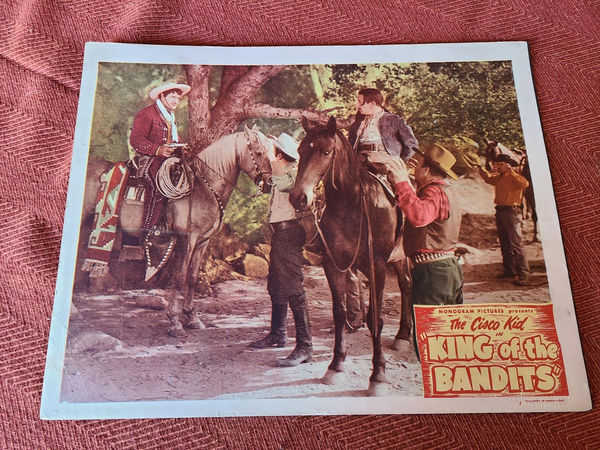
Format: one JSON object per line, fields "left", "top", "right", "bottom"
{"left": 496, "top": 206, "right": 529, "bottom": 279}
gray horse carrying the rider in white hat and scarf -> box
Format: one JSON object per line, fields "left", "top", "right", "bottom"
{"left": 83, "top": 127, "right": 272, "bottom": 337}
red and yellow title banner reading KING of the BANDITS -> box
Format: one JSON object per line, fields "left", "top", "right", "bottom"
{"left": 414, "top": 303, "right": 568, "bottom": 397}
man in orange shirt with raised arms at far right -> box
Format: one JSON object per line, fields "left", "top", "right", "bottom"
{"left": 479, "top": 155, "right": 530, "bottom": 286}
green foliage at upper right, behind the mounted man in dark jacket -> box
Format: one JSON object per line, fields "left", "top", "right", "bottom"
{"left": 320, "top": 61, "right": 524, "bottom": 151}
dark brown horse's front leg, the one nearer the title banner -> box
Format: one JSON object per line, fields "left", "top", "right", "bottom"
{"left": 367, "top": 261, "right": 387, "bottom": 396}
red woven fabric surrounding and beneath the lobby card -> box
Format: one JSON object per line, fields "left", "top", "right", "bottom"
{"left": 0, "top": 0, "right": 600, "bottom": 449}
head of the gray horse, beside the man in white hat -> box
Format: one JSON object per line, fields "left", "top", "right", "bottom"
{"left": 239, "top": 126, "right": 273, "bottom": 191}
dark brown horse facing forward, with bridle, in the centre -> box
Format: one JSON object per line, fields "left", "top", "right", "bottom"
{"left": 290, "top": 118, "right": 411, "bottom": 395}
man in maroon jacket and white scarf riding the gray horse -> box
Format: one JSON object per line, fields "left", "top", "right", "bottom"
{"left": 129, "top": 82, "right": 191, "bottom": 279}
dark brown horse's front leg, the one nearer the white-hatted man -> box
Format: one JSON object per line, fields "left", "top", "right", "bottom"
{"left": 322, "top": 262, "right": 346, "bottom": 384}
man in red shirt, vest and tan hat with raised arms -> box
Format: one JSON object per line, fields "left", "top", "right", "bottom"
{"left": 369, "top": 144, "right": 463, "bottom": 352}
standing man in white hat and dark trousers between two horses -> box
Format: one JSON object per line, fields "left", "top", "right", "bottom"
{"left": 250, "top": 133, "right": 312, "bottom": 367}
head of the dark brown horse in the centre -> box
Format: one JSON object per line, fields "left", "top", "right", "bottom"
{"left": 290, "top": 117, "right": 353, "bottom": 210}
